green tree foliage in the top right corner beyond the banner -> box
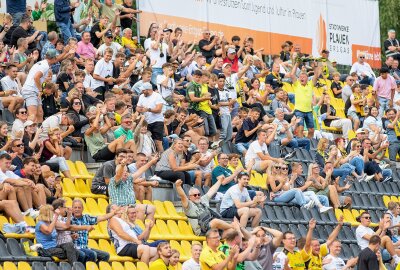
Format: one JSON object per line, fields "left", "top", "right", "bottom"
{"left": 379, "top": 0, "right": 400, "bottom": 57}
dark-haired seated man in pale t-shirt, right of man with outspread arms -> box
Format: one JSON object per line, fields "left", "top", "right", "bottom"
{"left": 220, "top": 172, "right": 266, "bottom": 228}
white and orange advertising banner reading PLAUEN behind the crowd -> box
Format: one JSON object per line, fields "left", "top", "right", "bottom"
{"left": 139, "top": 0, "right": 381, "bottom": 67}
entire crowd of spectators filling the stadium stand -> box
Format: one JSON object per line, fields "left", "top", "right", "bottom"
{"left": 0, "top": 0, "right": 400, "bottom": 270}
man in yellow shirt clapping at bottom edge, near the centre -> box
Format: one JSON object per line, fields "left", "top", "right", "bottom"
{"left": 199, "top": 229, "right": 239, "bottom": 270}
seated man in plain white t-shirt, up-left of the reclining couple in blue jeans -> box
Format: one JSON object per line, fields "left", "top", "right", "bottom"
{"left": 244, "top": 128, "right": 283, "bottom": 173}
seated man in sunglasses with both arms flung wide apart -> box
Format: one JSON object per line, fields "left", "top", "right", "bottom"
{"left": 175, "top": 180, "right": 237, "bottom": 235}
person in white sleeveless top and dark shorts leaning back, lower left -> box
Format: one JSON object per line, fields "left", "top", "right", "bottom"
{"left": 107, "top": 204, "right": 158, "bottom": 264}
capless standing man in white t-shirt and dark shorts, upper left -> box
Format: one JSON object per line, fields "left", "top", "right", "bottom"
{"left": 92, "top": 48, "right": 116, "bottom": 100}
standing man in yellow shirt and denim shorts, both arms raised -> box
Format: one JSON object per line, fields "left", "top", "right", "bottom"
{"left": 290, "top": 62, "right": 321, "bottom": 139}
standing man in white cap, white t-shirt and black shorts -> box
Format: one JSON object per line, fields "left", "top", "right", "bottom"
{"left": 136, "top": 82, "right": 164, "bottom": 152}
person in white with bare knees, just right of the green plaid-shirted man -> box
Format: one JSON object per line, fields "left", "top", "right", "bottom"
{"left": 128, "top": 152, "right": 158, "bottom": 201}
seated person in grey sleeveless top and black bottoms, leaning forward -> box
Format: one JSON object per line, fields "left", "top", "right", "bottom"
{"left": 155, "top": 138, "right": 195, "bottom": 185}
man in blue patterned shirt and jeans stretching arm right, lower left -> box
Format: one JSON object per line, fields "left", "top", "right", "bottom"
{"left": 71, "top": 199, "right": 113, "bottom": 261}
